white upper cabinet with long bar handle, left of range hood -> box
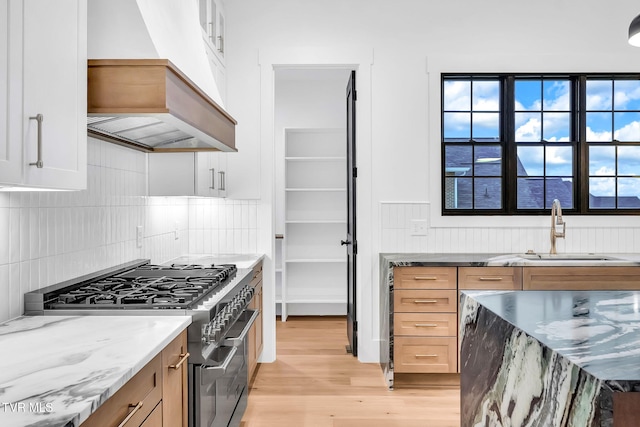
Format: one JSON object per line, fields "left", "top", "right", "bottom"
{"left": 0, "top": 0, "right": 87, "bottom": 190}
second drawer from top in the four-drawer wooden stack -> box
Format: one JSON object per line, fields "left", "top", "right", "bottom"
{"left": 393, "top": 289, "right": 457, "bottom": 313}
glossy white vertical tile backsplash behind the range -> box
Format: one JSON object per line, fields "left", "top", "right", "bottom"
{"left": 0, "top": 138, "right": 257, "bottom": 321}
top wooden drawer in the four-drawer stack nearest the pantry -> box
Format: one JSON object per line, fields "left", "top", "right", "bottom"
{"left": 393, "top": 267, "right": 457, "bottom": 289}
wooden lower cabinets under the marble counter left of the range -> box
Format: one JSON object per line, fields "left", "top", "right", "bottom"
{"left": 82, "top": 330, "right": 188, "bottom": 427}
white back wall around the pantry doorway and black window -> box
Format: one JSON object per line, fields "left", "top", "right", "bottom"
{"left": 227, "top": 0, "right": 640, "bottom": 362}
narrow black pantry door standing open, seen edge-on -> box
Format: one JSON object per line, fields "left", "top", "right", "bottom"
{"left": 342, "top": 71, "right": 358, "bottom": 356}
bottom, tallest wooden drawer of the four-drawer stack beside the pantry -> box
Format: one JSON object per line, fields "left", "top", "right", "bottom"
{"left": 393, "top": 337, "right": 458, "bottom": 374}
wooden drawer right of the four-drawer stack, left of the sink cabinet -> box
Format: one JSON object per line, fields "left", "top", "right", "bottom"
{"left": 458, "top": 267, "right": 522, "bottom": 290}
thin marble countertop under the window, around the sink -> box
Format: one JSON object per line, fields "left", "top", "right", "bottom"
{"left": 380, "top": 253, "right": 640, "bottom": 267}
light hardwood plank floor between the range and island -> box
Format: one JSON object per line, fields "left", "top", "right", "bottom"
{"left": 241, "top": 317, "right": 460, "bottom": 427}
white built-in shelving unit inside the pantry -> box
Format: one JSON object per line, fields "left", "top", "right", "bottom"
{"left": 278, "top": 129, "right": 347, "bottom": 321}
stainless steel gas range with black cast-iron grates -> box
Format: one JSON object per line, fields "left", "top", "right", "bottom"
{"left": 25, "top": 260, "right": 258, "bottom": 427}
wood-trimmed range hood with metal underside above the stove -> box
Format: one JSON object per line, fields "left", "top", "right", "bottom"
{"left": 87, "top": 59, "right": 237, "bottom": 152}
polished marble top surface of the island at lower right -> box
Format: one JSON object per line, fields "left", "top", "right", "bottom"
{"left": 461, "top": 291, "right": 640, "bottom": 381}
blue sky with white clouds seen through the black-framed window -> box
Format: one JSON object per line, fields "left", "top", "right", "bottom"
{"left": 443, "top": 79, "right": 640, "bottom": 205}
